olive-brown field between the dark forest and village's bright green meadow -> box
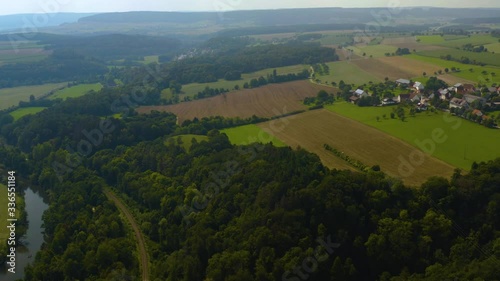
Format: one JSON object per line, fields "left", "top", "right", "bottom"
{"left": 259, "top": 109, "right": 454, "bottom": 185}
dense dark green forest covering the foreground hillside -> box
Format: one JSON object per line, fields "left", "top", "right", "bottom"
{"left": 2, "top": 84, "right": 500, "bottom": 280}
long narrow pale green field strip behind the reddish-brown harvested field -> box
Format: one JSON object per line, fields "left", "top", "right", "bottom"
{"left": 175, "top": 65, "right": 309, "bottom": 100}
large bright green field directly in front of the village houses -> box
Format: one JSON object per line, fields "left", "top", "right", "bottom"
{"left": 326, "top": 102, "right": 500, "bottom": 170}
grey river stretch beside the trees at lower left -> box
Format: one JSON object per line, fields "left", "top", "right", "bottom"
{"left": 0, "top": 188, "right": 49, "bottom": 281}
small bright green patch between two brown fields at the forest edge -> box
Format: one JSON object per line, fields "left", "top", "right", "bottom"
{"left": 221, "top": 124, "right": 287, "bottom": 147}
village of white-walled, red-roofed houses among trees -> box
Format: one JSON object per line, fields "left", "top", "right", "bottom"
{"left": 342, "top": 77, "right": 500, "bottom": 128}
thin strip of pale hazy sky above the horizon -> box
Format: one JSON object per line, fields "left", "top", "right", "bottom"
{"left": 0, "top": 0, "right": 500, "bottom": 15}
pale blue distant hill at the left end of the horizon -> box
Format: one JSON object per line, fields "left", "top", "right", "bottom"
{"left": 0, "top": 13, "right": 94, "bottom": 32}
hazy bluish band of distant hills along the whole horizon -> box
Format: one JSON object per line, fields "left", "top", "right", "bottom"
{"left": 0, "top": 7, "right": 500, "bottom": 35}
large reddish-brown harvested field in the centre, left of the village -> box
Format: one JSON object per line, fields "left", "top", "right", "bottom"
{"left": 137, "top": 81, "right": 334, "bottom": 124}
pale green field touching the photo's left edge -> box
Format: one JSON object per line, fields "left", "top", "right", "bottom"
{"left": 0, "top": 83, "right": 68, "bottom": 110}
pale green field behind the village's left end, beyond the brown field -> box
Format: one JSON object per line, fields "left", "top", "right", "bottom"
{"left": 316, "top": 61, "right": 382, "bottom": 84}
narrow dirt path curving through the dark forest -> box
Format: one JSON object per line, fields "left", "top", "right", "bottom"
{"left": 104, "top": 189, "right": 149, "bottom": 281}
